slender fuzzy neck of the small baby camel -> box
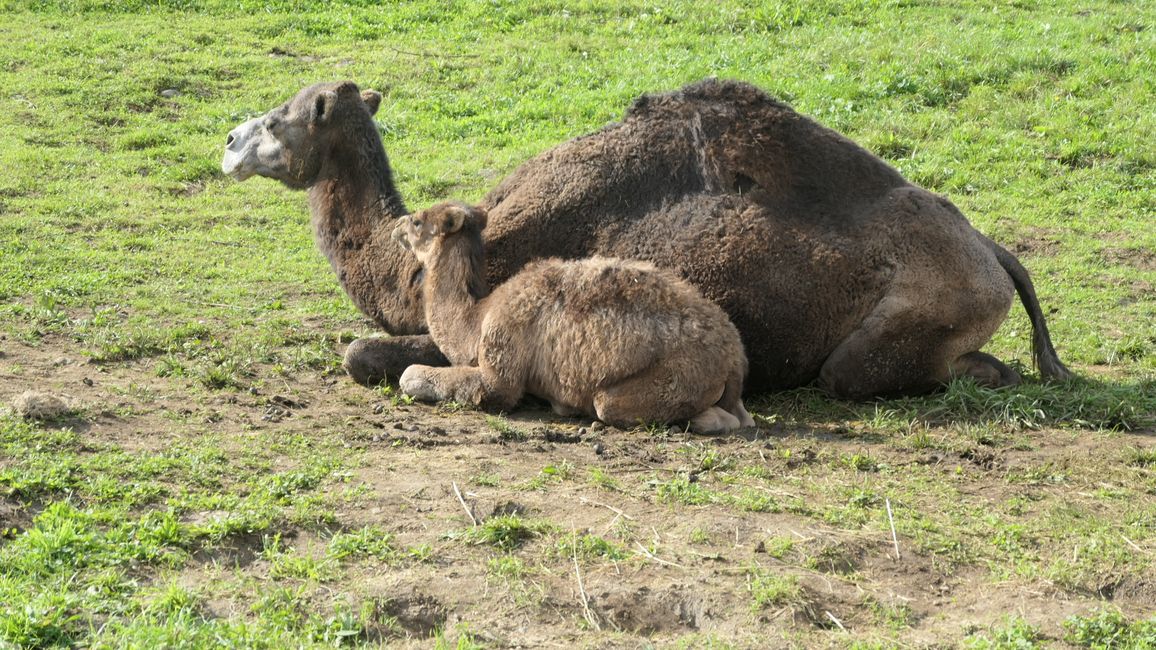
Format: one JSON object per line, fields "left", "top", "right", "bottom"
{"left": 423, "top": 232, "right": 490, "bottom": 365}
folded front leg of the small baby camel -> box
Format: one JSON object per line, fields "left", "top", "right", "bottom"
{"left": 398, "top": 364, "right": 521, "bottom": 409}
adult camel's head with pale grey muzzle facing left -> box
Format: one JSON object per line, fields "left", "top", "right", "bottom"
{"left": 221, "top": 81, "right": 381, "bottom": 190}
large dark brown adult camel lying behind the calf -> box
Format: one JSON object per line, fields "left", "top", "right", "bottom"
{"left": 222, "top": 80, "right": 1069, "bottom": 398}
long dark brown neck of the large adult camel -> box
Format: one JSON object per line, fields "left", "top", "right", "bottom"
{"left": 309, "top": 115, "right": 425, "bottom": 334}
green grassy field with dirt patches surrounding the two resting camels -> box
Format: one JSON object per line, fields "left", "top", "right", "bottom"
{"left": 0, "top": 0, "right": 1156, "bottom": 648}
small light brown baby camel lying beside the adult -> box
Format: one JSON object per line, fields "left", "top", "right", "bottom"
{"left": 393, "top": 202, "right": 755, "bottom": 434}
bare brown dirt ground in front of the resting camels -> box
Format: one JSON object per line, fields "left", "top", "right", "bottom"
{"left": 0, "top": 330, "right": 1156, "bottom": 648}
